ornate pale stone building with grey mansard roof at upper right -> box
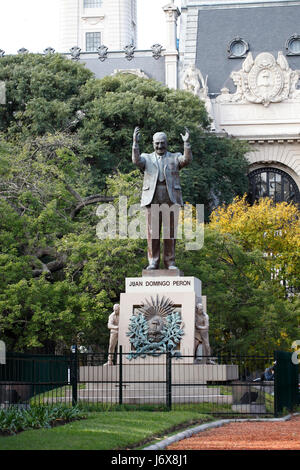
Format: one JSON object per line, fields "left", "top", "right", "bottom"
{"left": 179, "top": 0, "right": 300, "bottom": 202}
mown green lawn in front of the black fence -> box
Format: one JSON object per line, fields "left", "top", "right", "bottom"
{"left": 0, "top": 410, "right": 214, "bottom": 450}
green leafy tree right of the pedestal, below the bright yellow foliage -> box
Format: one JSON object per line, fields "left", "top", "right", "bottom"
{"left": 177, "top": 226, "right": 300, "bottom": 355}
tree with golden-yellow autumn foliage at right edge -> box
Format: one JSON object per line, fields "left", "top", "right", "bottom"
{"left": 210, "top": 196, "right": 300, "bottom": 291}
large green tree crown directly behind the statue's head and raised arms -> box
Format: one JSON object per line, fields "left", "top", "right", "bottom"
{"left": 79, "top": 75, "right": 248, "bottom": 214}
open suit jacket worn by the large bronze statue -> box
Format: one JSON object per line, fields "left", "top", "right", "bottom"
{"left": 132, "top": 146, "right": 192, "bottom": 207}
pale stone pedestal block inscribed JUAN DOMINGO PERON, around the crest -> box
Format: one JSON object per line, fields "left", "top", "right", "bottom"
{"left": 119, "top": 270, "right": 206, "bottom": 364}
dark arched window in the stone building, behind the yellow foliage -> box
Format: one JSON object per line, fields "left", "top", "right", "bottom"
{"left": 248, "top": 168, "right": 300, "bottom": 204}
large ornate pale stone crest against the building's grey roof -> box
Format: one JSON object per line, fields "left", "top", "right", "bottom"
{"left": 216, "top": 51, "right": 300, "bottom": 106}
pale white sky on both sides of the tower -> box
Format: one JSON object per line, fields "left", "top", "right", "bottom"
{"left": 0, "top": 0, "right": 181, "bottom": 54}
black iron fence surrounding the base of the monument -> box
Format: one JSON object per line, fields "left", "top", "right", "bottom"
{"left": 0, "top": 348, "right": 298, "bottom": 415}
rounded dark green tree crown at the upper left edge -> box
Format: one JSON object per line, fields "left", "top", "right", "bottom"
{"left": 0, "top": 54, "right": 93, "bottom": 138}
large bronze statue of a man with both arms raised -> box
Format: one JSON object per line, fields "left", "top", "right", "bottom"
{"left": 132, "top": 127, "right": 192, "bottom": 269}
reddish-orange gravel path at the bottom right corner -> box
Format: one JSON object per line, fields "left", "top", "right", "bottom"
{"left": 166, "top": 416, "right": 300, "bottom": 450}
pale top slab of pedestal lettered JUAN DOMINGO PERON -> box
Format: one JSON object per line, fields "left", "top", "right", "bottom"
{"left": 126, "top": 277, "right": 201, "bottom": 295}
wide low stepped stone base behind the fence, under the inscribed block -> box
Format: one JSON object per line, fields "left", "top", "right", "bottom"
{"left": 77, "top": 360, "right": 238, "bottom": 405}
